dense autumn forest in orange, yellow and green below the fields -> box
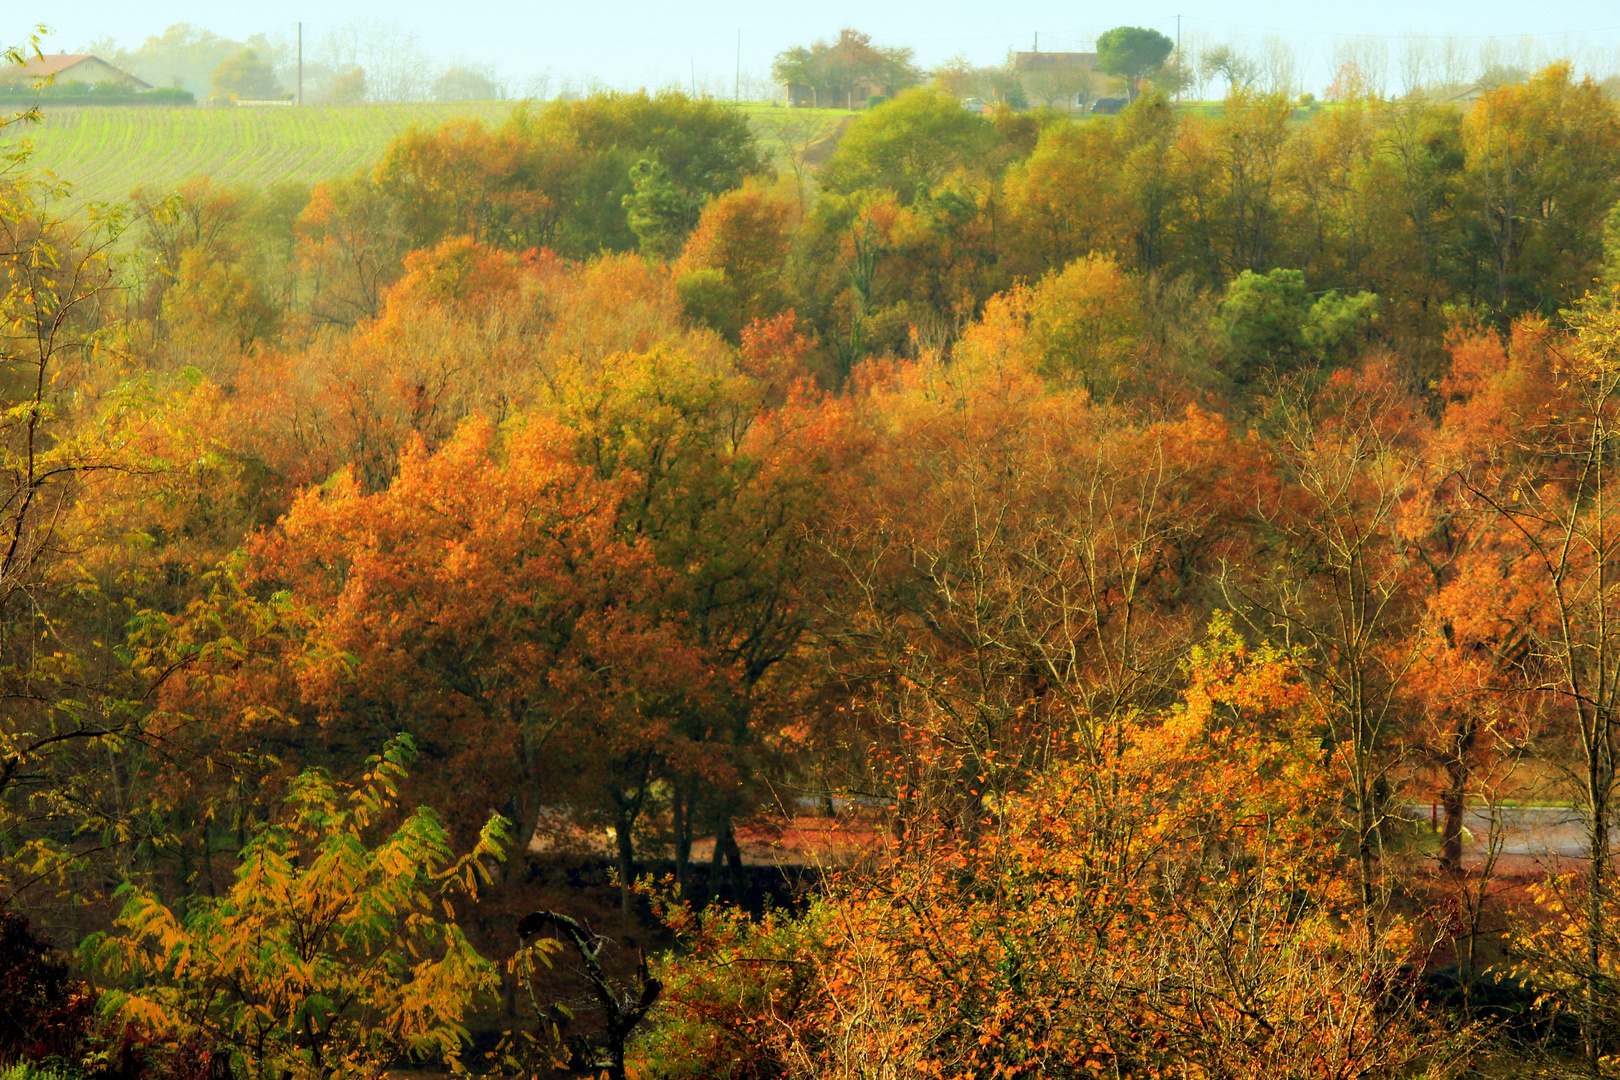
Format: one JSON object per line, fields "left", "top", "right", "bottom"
{"left": 0, "top": 40, "right": 1620, "bottom": 1080}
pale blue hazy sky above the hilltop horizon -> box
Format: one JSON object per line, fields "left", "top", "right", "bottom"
{"left": 0, "top": 0, "right": 1620, "bottom": 94}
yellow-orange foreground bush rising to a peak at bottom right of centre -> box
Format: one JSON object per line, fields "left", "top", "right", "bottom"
{"left": 648, "top": 620, "right": 1473, "bottom": 1078}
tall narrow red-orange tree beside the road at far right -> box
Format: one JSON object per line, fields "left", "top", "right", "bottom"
{"left": 1409, "top": 319, "right": 1578, "bottom": 868}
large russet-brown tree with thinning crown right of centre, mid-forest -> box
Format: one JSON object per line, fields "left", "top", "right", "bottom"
{"left": 825, "top": 341, "right": 1257, "bottom": 821}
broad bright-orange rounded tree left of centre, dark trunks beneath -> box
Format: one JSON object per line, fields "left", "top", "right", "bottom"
{"left": 160, "top": 419, "right": 710, "bottom": 913}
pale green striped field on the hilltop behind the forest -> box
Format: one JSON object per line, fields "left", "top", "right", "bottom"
{"left": 6, "top": 102, "right": 852, "bottom": 210}
